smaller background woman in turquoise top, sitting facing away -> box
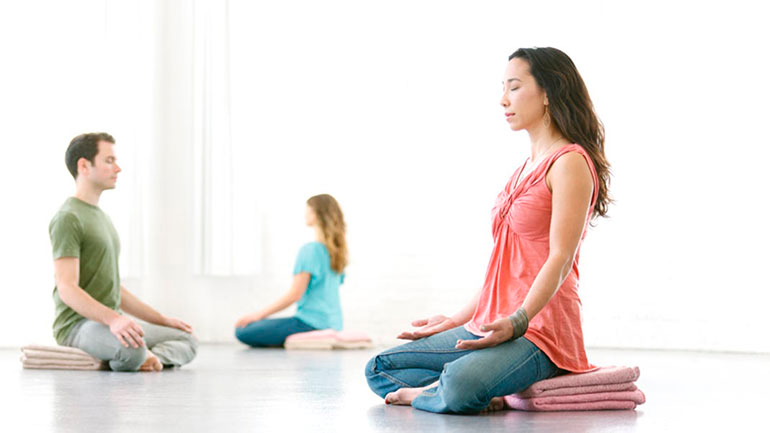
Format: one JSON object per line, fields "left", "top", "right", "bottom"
{"left": 235, "top": 194, "right": 348, "bottom": 347}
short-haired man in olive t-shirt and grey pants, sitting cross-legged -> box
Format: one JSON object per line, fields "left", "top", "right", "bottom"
{"left": 48, "top": 133, "right": 198, "bottom": 371}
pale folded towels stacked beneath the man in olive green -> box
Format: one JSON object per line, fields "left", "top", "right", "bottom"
{"left": 21, "top": 344, "right": 107, "bottom": 370}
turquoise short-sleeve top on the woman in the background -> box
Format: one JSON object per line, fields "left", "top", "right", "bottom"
{"left": 294, "top": 242, "right": 345, "bottom": 331}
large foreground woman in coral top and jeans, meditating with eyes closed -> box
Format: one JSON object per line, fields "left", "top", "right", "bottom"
{"left": 366, "top": 48, "right": 610, "bottom": 413}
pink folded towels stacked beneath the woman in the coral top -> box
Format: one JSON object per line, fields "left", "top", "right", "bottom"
{"left": 505, "top": 366, "right": 645, "bottom": 411}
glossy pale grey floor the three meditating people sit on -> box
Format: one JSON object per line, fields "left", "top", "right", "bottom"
{"left": 0, "top": 344, "right": 770, "bottom": 433}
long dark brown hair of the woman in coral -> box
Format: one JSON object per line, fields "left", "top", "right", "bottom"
{"left": 508, "top": 47, "right": 612, "bottom": 218}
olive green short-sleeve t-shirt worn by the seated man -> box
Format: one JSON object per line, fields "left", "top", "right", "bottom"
{"left": 48, "top": 197, "right": 120, "bottom": 344}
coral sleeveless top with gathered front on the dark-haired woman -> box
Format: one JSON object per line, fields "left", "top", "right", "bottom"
{"left": 465, "top": 144, "right": 599, "bottom": 373}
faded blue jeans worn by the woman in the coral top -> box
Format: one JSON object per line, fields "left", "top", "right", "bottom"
{"left": 366, "top": 327, "right": 561, "bottom": 413}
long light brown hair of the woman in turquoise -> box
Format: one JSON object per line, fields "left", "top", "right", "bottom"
{"left": 307, "top": 194, "right": 348, "bottom": 274}
